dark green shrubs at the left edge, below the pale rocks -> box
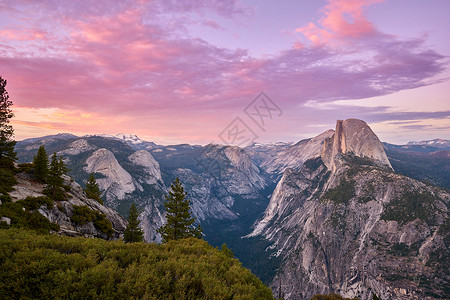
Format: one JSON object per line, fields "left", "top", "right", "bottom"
{"left": 0, "top": 197, "right": 59, "bottom": 233}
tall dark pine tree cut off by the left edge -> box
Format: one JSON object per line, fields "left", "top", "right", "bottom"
{"left": 0, "top": 77, "right": 17, "bottom": 170}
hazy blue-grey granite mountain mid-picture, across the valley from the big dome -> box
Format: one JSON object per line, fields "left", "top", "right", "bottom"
{"left": 173, "top": 145, "right": 267, "bottom": 220}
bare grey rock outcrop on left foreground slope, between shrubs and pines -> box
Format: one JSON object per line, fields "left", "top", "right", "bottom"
{"left": 10, "top": 173, "right": 128, "bottom": 239}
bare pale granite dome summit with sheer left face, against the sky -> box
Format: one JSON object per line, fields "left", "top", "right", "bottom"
{"left": 321, "top": 119, "right": 392, "bottom": 169}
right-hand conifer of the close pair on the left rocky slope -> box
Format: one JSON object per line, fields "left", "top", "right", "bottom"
{"left": 44, "top": 153, "right": 68, "bottom": 201}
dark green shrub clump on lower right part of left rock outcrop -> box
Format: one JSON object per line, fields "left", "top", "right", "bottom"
{"left": 70, "top": 205, "right": 114, "bottom": 236}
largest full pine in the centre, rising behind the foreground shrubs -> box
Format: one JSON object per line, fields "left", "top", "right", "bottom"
{"left": 158, "top": 178, "right": 202, "bottom": 242}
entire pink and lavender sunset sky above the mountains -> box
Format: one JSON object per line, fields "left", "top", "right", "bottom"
{"left": 0, "top": 0, "right": 450, "bottom": 146}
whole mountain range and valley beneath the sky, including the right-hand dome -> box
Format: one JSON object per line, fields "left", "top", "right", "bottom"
{"left": 16, "top": 119, "right": 450, "bottom": 299}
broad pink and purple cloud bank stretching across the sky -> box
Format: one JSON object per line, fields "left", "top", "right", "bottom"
{"left": 0, "top": 0, "right": 444, "bottom": 144}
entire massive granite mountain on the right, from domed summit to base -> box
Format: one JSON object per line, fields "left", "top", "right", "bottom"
{"left": 250, "top": 120, "right": 450, "bottom": 300}
